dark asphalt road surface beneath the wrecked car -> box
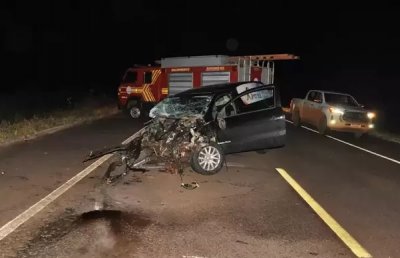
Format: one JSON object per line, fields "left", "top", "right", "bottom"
{"left": 0, "top": 115, "right": 400, "bottom": 257}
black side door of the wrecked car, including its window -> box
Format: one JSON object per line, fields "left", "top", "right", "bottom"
{"left": 217, "top": 85, "right": 286, "bottom": 153}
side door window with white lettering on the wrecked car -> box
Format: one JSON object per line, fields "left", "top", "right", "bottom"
{"left": 224, "top": 89, "right": 275, "bottom": 117}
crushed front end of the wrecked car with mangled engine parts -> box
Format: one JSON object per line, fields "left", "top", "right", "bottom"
{"left": 85, "top": 116, "right": 224, "bottom": 183}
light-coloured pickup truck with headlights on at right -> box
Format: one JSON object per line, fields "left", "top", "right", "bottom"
{"left": 290, "top": 90, "right": 375, "bottom": 137}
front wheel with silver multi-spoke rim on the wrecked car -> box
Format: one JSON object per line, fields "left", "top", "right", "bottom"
{"left": 190, "top": 143, "right": 225, "bottom": 176}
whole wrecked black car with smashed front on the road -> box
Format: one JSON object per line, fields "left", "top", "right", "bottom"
{"left": 84, "top": 82, "right": 286, "bottom": 182}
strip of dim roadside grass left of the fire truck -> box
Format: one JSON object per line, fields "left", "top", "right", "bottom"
{"left": 0, "top": 101, "right": 118, "bottom": 145}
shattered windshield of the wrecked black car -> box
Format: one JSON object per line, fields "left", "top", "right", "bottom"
{"left": 150, "top": 95, "right": 212, "bottom": 118}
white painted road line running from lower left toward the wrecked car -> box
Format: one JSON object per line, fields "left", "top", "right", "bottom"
{"left": 0, "top": 127, "right": 145, "bottom": 241}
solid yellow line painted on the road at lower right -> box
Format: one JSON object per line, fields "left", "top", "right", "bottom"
{"left": 276, "top": 168, "right": 372, "bottom": 258}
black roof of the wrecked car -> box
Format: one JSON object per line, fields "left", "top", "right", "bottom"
{"left": 174, "top": 81, "right": 264, "bottom": 97}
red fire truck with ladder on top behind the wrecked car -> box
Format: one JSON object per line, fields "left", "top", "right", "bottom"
{"left": 118, "top": 54, "right": 299, "bottom": 118}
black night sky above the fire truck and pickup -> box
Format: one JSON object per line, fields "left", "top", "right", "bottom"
{"left": 0, "top": 0, "right": 400, "bottom": 128}
